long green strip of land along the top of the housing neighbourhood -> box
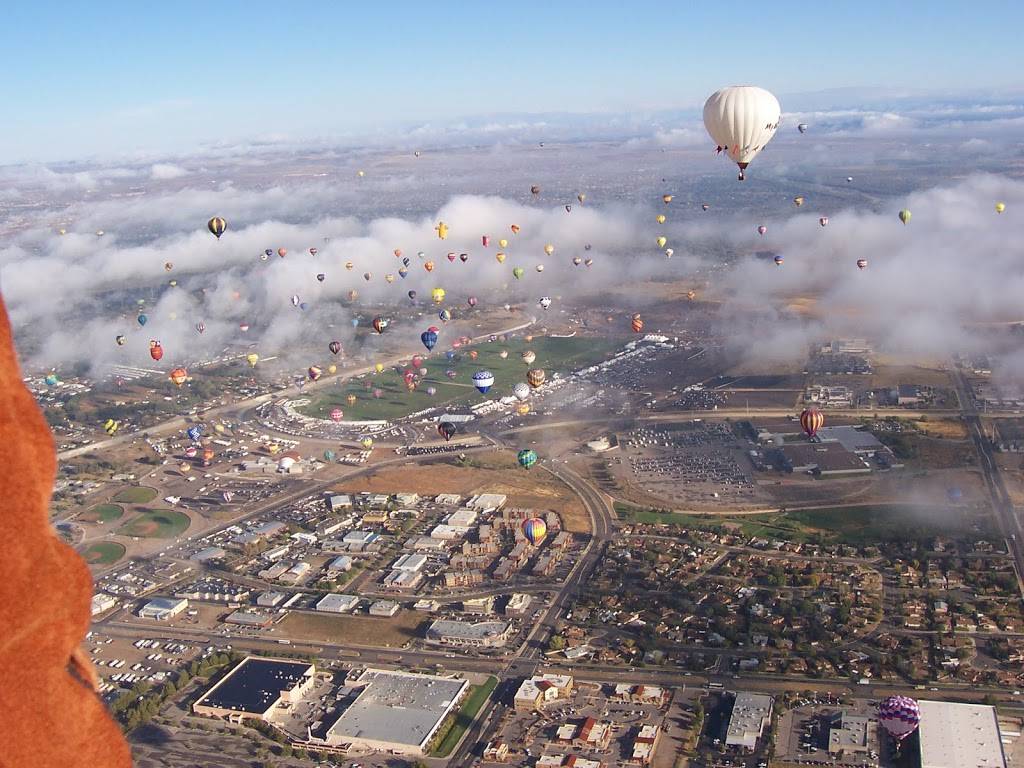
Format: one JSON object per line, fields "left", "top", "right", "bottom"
{"left": 615, "top": 504, "right": 985, "bottom": 545}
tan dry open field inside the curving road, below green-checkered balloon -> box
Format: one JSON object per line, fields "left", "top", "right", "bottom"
{"left": 350, "top": 453, "right": 590, "bottom": 534}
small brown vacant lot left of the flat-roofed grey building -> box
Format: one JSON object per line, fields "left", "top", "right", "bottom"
{"left": 279, "top": 610, "right": 427, "bottom": 648}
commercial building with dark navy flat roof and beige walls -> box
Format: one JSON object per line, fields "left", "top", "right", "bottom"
{"left": 193, "top": 656, "right": 316, "bottom": 722}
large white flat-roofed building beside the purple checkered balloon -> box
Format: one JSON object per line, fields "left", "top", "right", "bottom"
{"left": 918, "top": 700, "right": 1007, "bottom": 768}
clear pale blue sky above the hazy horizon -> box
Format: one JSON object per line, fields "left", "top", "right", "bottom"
{"left": 0, "top": 0, "right": 1024, "bottom": 163}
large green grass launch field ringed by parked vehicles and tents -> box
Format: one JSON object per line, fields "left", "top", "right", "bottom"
{"left": 299, "top": 336, "right": 624, "bottom": 420}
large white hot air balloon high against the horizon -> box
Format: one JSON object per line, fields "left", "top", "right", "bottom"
{"left": 703, "top": 85, "right": 781, "bottom": 181}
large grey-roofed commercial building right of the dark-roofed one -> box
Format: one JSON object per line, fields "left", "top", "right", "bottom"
{"left": 325, "top": 669, "right": 469, "bottom": 755}
